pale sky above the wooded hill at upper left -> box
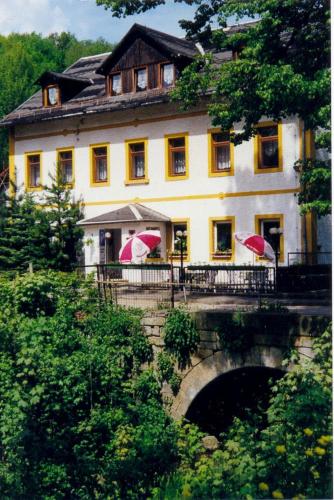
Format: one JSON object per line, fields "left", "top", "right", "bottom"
{"left": 0, "top": 0, "right": 70, "bottom": 35}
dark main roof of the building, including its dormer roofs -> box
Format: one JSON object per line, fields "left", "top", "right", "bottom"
{"left": 0, "top": 23, "right": 252, "bottom": 127}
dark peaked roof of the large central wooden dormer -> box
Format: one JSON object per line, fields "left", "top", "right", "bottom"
{"left": 96, "top": 23, "right": 199, "bottom": 75}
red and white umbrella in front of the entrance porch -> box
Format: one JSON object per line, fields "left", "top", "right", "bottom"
{"left": 119, "top": 230, "right": 161, "bottom": 264}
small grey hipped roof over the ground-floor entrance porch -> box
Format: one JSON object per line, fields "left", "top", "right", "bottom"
{"left": 78, "top": 203, "right": 170, "bottom": 226}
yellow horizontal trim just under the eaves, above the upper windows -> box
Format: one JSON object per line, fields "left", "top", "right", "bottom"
{"left": 16, "top": 111, "right": 207, "bottom": 141}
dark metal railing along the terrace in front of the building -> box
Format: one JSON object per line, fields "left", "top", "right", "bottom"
{"left": 78, "top": 264, "right": 275, "bottom": 308}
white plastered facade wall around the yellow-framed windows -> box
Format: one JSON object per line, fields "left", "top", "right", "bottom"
{"left": 15, "top": 105, "right": 301, "bottom": 264}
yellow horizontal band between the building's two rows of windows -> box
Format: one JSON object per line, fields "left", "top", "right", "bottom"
{"left": 83, "top": 188, "right": 300, "bottom": 207}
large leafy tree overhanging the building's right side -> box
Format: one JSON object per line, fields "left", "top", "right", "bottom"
{"left": 97, "top": 0, "right": 330, "bottom": 215}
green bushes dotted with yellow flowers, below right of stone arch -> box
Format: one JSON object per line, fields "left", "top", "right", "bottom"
{"left": 155, "top": 325, "right": 332, "bottom": 500}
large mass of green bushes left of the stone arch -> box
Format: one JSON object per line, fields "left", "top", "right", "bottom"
{"left": 0, "top": 272, "right": 178, "bottom": 499}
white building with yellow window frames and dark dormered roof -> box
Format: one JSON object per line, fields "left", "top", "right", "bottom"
{"left": 2, "top": 25, "right": 317, "bottom": 265}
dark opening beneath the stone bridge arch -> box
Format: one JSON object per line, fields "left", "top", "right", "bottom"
{"left": 185, "top": 367, "right": 284, "bottom": 437}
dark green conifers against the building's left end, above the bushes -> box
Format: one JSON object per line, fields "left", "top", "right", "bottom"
{"left": 0, "top": 176, "right": 83, "bottom": 271}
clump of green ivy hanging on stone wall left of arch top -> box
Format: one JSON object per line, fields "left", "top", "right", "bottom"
{"left": 164, "top": 308, "right": 200, "bottom": 368}
